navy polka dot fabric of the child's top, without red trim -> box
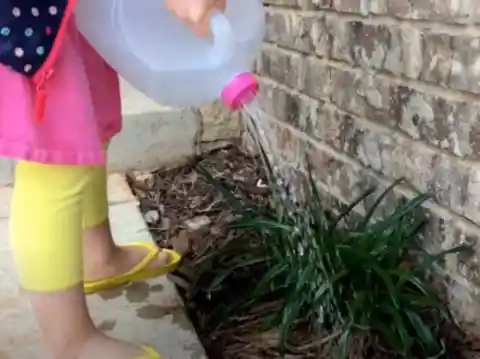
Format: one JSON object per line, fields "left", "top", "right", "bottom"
{"left": 0, "top": 0, "right": 69, "bottom": 77}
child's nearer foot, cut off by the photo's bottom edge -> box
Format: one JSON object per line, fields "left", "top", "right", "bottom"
{"left": 77, "top": 333, "right": 156, "bottom": 359}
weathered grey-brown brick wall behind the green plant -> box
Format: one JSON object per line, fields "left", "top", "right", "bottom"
{"left": 251, "top": 0, "right": 480, "bottom": 333}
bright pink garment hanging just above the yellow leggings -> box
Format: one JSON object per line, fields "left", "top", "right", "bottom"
{"left": 0, "top": 17, "right": 121, "bottom": 165}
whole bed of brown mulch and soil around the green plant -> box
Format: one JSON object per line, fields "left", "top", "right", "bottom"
{"left": 129, "top": 147, "right": 480, "bottom": 359}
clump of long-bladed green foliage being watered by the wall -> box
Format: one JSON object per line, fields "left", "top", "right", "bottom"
{"left": 193, "top": 148, "right": 471, "bottom": 359}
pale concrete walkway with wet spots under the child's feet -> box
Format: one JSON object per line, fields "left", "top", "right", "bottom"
{"left": 0, "top": 175, "right": 205, "bottom": 359}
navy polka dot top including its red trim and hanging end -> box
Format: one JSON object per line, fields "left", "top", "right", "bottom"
{"left": 0, "top": 0, "right": 75, "bottom": 122}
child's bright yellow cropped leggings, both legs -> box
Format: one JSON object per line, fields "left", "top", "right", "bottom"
{"left": 10, "top": 161, "right": 108, "bottom": 292}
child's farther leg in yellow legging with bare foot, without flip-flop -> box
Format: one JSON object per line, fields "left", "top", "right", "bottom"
{"left": 83, "top": 167, "right": 170, "bottom": 280}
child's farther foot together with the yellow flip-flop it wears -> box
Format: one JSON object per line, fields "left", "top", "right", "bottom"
{"left": 84, "top": 243, "right": 180, "bottom": 293}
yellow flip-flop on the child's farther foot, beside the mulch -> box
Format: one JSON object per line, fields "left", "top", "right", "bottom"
{"left": 83, "top": 243, "right": 182, "bottom": 294}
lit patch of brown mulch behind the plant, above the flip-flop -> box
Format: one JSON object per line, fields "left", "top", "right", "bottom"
{"left": 128, "top": 147, "right": 269, "bottom": 253}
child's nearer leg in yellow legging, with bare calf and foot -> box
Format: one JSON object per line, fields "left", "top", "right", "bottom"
{"left": 10, "top": 162, "right": 146, "bottom": 359}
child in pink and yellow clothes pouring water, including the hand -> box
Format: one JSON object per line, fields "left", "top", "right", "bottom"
{"left": 0, "top": 0, "right": 225, "bottom": 359}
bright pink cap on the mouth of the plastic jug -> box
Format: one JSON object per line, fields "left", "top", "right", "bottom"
{"left": 222, "top": 72, "right": 258, "bottom": 110}
